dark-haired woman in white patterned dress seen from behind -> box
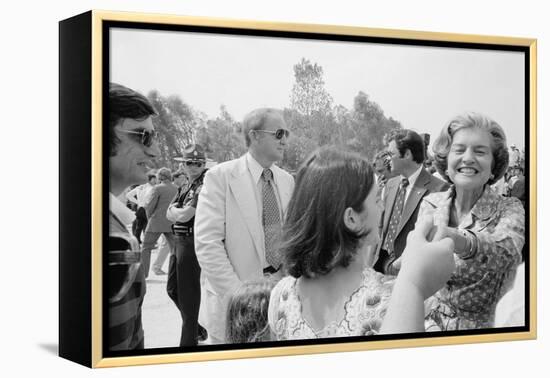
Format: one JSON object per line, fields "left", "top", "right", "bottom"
{"left": 269, "top": 147, "right": 393, "bottom": 340}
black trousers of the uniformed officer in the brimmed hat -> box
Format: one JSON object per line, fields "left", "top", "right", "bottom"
{"left": 166, "top": 235, "right": 201, "bottom": 346}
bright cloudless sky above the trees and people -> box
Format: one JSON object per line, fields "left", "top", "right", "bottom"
{"left": 110, "top": 29, "right": 525, "bottom": 148}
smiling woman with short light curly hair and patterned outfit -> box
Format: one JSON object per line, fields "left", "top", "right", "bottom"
{"left": 418, "top": 113, "right": 525, "bottom": 331}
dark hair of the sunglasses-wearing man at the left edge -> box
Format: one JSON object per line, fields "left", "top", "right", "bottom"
{"left": 109, "top": 83, "right": 156, "bottom": 156}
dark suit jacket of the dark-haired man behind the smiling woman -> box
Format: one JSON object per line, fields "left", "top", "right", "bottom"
{"left": 374, "top": 168, "right": 449, "bottom": 275}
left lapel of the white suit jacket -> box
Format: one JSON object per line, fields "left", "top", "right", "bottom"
{"left": 229, "top": 157, "right": 265, "bottom": 261}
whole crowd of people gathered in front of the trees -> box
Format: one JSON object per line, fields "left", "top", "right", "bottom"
{"left": 107, "top": 84, "right": 526, "bottom": 350}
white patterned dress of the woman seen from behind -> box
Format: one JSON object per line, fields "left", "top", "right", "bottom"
{"left": 269, "top": 268, "right": 395, "bottom": 340}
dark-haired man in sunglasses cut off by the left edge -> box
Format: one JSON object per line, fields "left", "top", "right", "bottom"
{"left": 108, "top": 84, "right": 160, "bottom": 351}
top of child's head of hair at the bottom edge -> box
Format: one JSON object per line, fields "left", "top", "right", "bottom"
{"left": 225, "top": 278, "right": 276, "bottom": 343}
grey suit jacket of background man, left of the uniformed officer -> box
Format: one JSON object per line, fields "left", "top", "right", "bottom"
{"left": 144, "top": 182, "right": 178, "bottom": 232}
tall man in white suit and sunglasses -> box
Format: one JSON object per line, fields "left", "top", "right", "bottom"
{"left": 195, "top": 108, "right": 294, "bottom": 344}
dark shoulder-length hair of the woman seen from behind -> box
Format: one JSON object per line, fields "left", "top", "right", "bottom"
{"left": 280, "top": 147, "right": 374, "bottom": 278}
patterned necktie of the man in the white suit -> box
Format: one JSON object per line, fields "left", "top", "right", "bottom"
{"left": 262, "top": 169, "right": 281, "bottom": 269}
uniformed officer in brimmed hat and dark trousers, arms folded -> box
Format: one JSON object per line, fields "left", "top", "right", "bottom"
{"left": 166, "top": 144, "right": 206, "bottom": 346}
